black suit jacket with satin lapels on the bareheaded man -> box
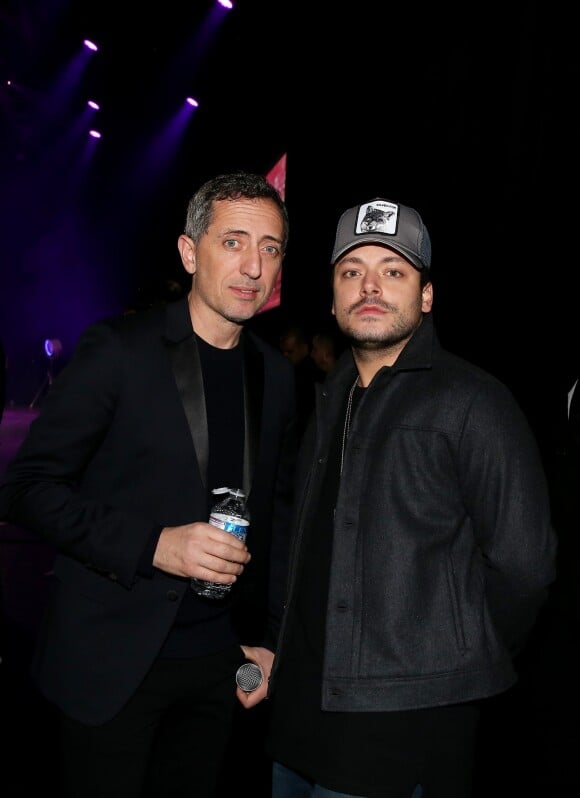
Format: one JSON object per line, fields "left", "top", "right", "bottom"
{"left": 0, "top": 298, "right": 295, "bottom": 723}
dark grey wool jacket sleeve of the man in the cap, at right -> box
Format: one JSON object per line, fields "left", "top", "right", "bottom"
{"left": 459, "top": 382, "right": 556, "bottom": 656}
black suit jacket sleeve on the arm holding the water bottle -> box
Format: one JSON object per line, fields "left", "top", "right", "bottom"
{"left": 0, "top": 323, "right": 158, "bottom": 586}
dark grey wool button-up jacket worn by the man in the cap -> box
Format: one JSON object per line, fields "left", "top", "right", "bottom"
{"left": 271, "top": 315, "right": 556, "bottom": 712}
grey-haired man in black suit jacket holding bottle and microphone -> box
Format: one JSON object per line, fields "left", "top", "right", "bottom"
{"left": 0, "top": 173, "right": 296, "bottom": 798}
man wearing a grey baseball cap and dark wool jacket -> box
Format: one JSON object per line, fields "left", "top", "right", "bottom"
{"left": 267, "top": 197, "right": 556, "bottom": 798}
